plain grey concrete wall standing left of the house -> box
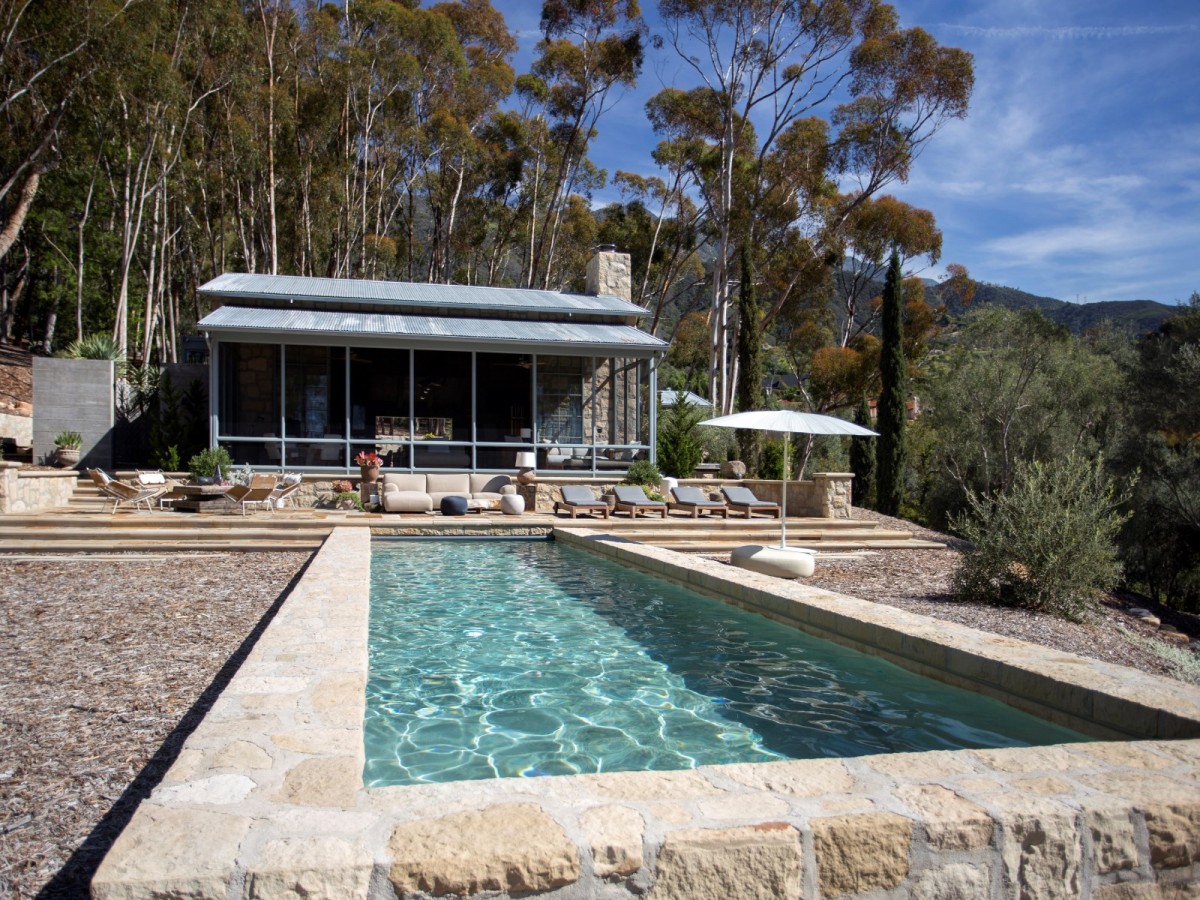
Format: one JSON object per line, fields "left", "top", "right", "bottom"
{"left": 34, "top": 356, "right": 115, "bottom": 469}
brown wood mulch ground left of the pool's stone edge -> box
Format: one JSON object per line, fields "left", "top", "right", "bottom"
{"left": 0, "top": 552, "right": 311, "bottom": 898}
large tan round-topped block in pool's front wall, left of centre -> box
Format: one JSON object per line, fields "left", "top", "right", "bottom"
{"left": 388, "top": 803, "right": 580, "bottom": 895}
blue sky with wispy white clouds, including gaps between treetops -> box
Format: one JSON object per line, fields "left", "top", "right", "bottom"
{"left": 493, "top": 0, "right": 1200, "bottom": 302}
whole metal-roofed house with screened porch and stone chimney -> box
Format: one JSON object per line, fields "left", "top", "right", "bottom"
{"left": 199, "top": 247, "right": 666, "bottom": 472}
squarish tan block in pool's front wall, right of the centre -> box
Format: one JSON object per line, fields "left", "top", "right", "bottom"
{"left": 812, "top": 812, "right": 912, "bottom": 896}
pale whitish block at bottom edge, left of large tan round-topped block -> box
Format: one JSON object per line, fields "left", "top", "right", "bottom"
{"left": 245, "top": 838, "right": 372, "bottom": 900}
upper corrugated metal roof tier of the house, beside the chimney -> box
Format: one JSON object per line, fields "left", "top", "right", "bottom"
{"left": 199, "top": 272, "right": 646, "bottom": 317}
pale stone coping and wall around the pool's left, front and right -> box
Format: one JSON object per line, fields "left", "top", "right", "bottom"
{"left": 92, "top": 527, "right": 1200, "bottom": 900}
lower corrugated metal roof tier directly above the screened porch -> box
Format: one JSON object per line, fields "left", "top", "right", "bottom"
{"left": 199, "top": 306, "right": 666, "bottom": 355}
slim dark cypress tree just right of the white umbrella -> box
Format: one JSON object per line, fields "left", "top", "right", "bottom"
{"left": 875, "top": 247, "right": 908, "bottom": 516}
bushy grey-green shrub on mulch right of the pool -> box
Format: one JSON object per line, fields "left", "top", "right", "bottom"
{"left": 952, "top": 454, "right": 1128, "bottom": 620}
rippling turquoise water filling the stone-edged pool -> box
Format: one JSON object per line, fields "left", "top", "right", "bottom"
{"left": 365, "top": 541, "right": 1086, "bottom": 787}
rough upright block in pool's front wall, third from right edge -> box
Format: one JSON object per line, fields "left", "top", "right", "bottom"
{"left": 995, "top": 793, "right": 1084, "bottom": 898}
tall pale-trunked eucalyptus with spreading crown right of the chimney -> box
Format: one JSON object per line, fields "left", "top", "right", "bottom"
{"left": 660, "top": 0, "right": 973, "bottom": 412}
